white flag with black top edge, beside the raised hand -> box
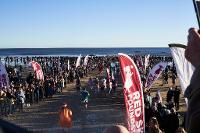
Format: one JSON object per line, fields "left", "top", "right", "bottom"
{"left": 169, "top": 44, "right": 194, "bottom": 94}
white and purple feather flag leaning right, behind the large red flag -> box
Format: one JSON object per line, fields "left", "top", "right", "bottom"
{"left": 145, "top": 62, "right": 168, "bottom": 89}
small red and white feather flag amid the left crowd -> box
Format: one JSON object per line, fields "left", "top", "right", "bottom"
{"left": 30, "top": 61, "right": 44, "bottom": 81}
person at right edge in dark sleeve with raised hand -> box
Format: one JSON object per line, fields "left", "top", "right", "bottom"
{"left": 184, "top": 28, "right": 200, "bottom": 133}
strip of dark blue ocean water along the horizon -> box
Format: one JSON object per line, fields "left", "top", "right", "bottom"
{"left": 0, "top": 48, "right": 171, "bottom": 56}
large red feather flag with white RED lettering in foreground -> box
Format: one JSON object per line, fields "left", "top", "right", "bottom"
{"left": 118, "top": 53, "right": 145, "bottom": 133}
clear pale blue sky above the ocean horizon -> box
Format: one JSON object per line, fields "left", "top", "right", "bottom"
{"left": 0, "top": 0, "right": 198, "bottom": 48}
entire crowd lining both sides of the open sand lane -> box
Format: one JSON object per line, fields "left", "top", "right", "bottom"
{"left": 0, "top": 53, "right": 187, "bottom": 133}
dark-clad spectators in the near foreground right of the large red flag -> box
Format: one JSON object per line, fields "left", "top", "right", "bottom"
{"left": 144, "top": 88, "right": 184, "bottom": 133}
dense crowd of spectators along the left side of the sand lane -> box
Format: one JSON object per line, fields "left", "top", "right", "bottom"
{"left": 0, "top": 57, "right": 96, "bottom": 116}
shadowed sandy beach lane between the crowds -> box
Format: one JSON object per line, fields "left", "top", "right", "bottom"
{"left": 0, "top": 58, "right": 186, "bottom": 133}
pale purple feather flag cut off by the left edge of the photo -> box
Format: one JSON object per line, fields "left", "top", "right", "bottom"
{"left": 0, "top": 61, "right": 9, "bottom": 89}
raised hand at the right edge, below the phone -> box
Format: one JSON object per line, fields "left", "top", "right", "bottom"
{"left": 185, "top": 28, "right": 200, "bottom": 67}
